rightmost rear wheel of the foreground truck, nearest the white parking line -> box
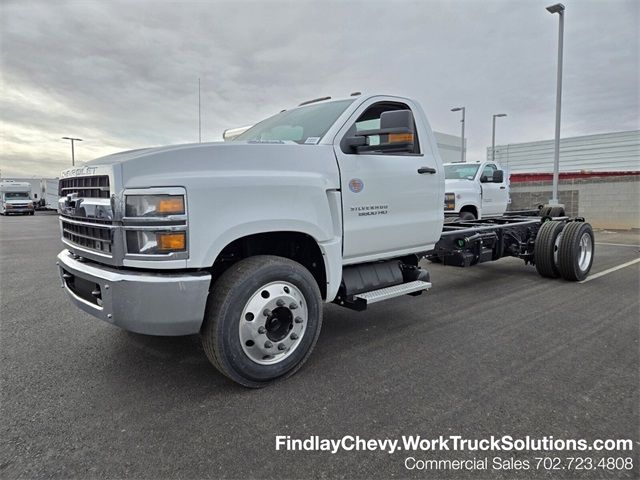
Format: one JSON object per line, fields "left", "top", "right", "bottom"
{"left": 558, "top": 222, "right": 595, "bottom": 282}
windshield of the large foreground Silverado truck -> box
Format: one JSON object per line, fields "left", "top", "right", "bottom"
{"left": 233, "top": 100, "right": 353, "bottom": 145}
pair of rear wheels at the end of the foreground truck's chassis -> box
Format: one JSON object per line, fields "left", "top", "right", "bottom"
{"left": 534, "top": 220, "right": 595, "bottom": 281}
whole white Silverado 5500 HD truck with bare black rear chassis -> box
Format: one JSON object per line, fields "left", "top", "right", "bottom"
{"left": 57, "top": 95, "right": 594, "bottom": 387}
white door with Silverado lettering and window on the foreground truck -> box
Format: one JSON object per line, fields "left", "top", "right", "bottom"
{"left": 334, "top": 100, "right": 444, "bottom": 264}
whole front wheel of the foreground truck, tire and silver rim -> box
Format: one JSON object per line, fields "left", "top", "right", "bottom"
{"left": 201, "top": 255, "right": 322, "bottom": 388}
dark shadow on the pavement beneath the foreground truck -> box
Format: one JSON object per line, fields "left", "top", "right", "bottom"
{"left": 104, "top": 255, "right": 584, "bottom": 397}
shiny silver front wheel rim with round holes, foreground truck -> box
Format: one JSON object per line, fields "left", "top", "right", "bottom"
{"left": 238, "top": 282, "right": 309, "bottom": 365}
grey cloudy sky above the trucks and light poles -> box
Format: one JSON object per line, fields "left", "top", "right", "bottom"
{"left": 0, "top": 0, "right": 640, "bottom": 177}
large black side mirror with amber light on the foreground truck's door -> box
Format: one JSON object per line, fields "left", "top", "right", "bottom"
{"left": 344, "top": 110, "right": 416, "bottom": 153}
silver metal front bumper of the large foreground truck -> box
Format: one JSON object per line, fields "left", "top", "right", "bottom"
{"left": 57, "top": 250, "right": 211, "bottom": 335}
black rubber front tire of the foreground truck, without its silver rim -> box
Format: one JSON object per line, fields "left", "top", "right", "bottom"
{"left": 200, "top": 255, "right": 322, "bottom": 388}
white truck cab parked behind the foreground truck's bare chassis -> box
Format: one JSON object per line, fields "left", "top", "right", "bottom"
{"left": 444, "top": 161, "right": 510, "bottom": 220}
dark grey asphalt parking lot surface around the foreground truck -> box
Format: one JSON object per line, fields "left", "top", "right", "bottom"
{"left": 0, "top": 213, "right": 640, "bottom": 479}
